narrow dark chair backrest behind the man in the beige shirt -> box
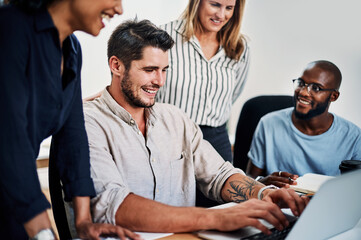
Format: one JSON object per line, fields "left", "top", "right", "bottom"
{"left": 49, "top": 161, "right": 72, "bottom": 240}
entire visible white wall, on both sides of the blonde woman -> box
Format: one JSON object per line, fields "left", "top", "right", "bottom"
{"left": 77, "top": 0, "right": 361, "bottom": 142}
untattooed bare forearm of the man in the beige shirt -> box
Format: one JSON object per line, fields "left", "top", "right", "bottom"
{"left": 115, "top": 194, "right": 216, "bottom": 232}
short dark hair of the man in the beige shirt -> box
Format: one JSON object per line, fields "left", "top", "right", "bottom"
{"left": 108, "top": 20, "right": 174, "bottom": 69}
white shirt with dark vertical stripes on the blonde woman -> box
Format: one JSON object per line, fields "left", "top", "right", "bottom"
{"left": 157, "top": 20, "right": 249, "bottom": 127}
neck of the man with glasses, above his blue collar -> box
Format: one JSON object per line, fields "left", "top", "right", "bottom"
{"left": 292, "top": 111, "right": 333, "bottom": 136}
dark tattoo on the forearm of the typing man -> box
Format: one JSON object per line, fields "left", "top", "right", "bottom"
{"left": 227, "top": 178, "right": 258, "bottom": 203}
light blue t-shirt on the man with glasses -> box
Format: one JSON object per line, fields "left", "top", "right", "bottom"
{"left": 248, "top": 107, "right": 361, "bottom": 176}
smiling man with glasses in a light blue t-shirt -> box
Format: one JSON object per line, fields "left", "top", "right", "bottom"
{"left": 247, "top": 60, "right": 361, "bottom": 187}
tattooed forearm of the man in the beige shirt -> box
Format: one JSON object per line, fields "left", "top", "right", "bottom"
{"left": 222, "top": 174, "right": 264, "bottom": 203}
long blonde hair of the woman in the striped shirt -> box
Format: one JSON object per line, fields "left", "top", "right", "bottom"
{"left": 181, "top": 0, "right": 246, "bottom": 60}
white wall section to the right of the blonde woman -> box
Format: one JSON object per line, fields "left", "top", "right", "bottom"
{"left": 229, "top": 0, "right": 361, "bottom": 139}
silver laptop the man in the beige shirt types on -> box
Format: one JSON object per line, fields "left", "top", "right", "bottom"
{"left": 198, "top": 170, "right": 361, "bottom": 240}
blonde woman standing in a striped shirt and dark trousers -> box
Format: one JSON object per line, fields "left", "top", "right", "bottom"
{"left": 157, "top": 0, "right": 249, "bottom": 165}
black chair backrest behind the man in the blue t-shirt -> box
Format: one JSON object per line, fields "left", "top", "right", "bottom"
{"left": 233, "top": 95, "right": 294, "bottom": 171}
